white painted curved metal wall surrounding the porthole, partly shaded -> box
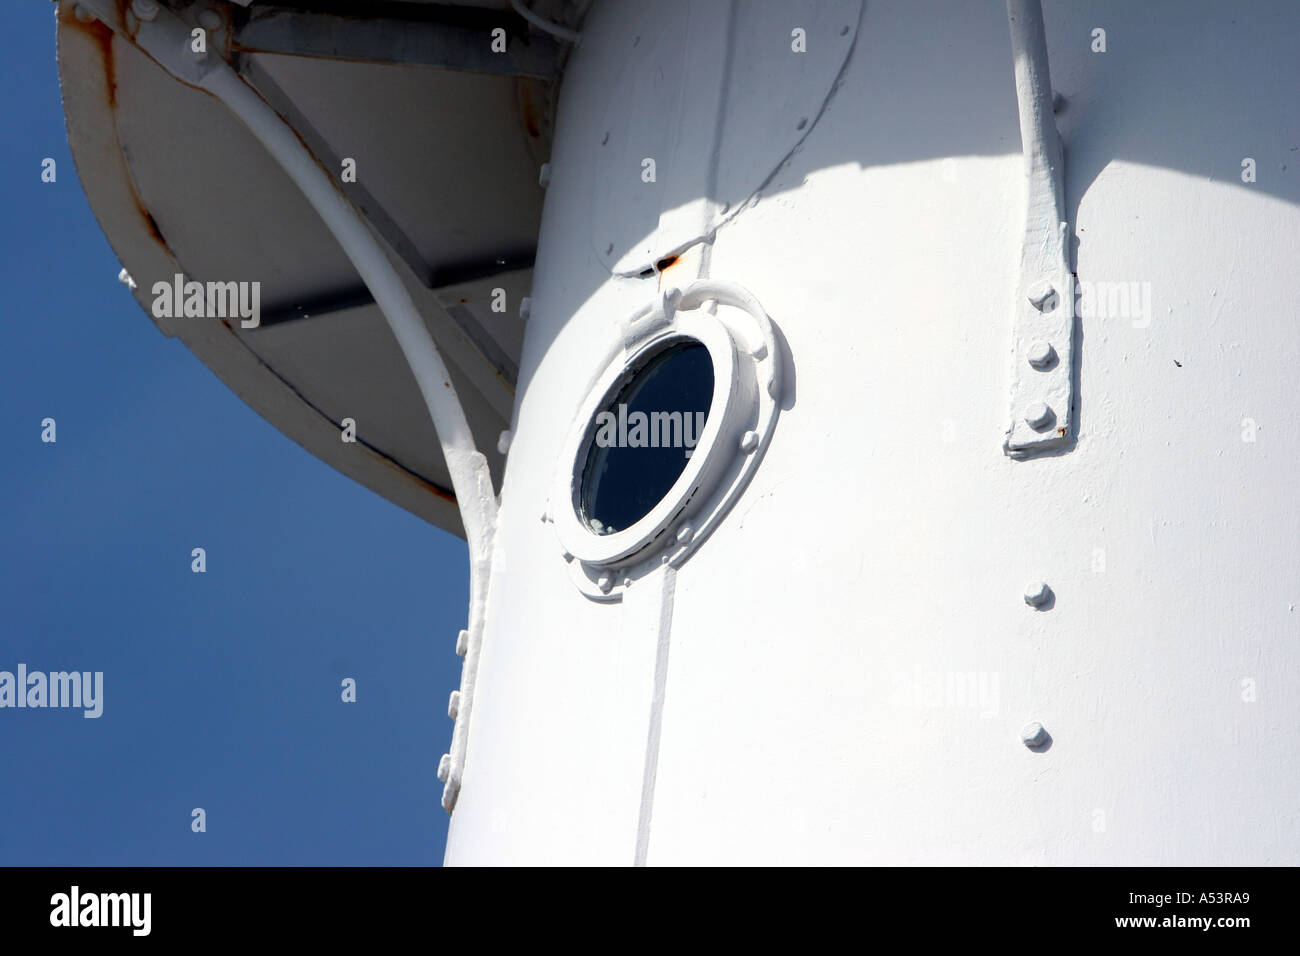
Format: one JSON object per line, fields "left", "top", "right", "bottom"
{"left": 447, "top": 0, "right": 1300, "bottom": 864}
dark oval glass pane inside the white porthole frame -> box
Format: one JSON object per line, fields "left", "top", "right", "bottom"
{"left": 579, "top": 338, "right": 714, "bottom": 535}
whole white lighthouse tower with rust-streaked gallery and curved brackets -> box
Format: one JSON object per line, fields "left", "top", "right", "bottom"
{"left": 59, "top": 0, "right": 1300, "bottom": 865}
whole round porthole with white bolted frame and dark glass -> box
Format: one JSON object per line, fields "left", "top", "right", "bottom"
{"left": 546, "top": 280, "right": 780, "bottom": 601}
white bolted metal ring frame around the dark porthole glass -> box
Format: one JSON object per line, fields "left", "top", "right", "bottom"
{"left": 547, "top": 278, "right": 781, "bottom": 601}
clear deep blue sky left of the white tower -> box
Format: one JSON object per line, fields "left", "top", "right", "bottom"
{"left": 0, "top": 0, "right": 468, "bottom": 865}
